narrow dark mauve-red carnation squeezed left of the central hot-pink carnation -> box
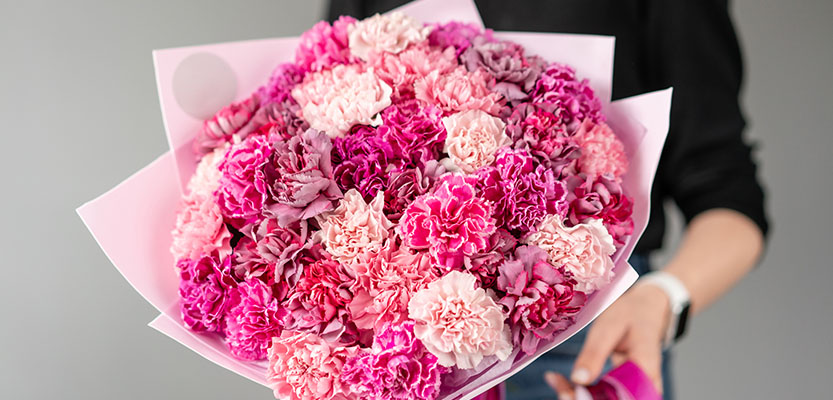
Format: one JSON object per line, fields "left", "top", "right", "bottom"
{"left": 384, "top": 160, "right": 446, "bottom": 222}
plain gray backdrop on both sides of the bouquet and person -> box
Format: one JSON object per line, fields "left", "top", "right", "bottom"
{"left": 0, "top": 0, "right": 833, "bottom": 399}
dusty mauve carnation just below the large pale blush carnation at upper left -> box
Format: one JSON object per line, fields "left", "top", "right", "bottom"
{"left": 264, "top": 129, "right": 342, "bottom": 226}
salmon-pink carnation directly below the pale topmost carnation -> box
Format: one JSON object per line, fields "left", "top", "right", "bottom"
{"left": 368, "top": 45, "right": 458, "bottom": 98}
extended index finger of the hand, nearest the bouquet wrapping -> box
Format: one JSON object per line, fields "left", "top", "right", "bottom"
{"left": 570, "top": 309, "right": 627, "bottom": 385}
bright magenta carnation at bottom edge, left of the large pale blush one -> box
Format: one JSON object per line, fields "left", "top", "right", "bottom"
{"left": 341, "top": 321, "right": 446, "bottom": 400}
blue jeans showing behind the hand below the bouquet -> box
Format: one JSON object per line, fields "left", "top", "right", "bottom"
{"left": 506, "top": 254, "right": 673, "bottom": 400}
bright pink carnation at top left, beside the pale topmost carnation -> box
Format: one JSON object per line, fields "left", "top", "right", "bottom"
{"left": 295, "top": 16, "right": 356, "bottom": 72}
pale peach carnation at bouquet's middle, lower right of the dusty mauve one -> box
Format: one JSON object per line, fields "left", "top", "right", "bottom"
{"left": 316, "top": 189, "right": 393, "bottom": 264}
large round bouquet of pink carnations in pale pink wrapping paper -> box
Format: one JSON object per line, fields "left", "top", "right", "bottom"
{"left": 79, "top": 1, "right": 668, "bottom": 400}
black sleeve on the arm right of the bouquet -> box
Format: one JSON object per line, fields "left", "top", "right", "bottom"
{"left": 647, "top": 0, "right": 768, "bottom": 238}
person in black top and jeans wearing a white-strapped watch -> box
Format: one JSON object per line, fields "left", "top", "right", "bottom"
{"left": 329, "top": 0, "right": 768, "bottom": 400}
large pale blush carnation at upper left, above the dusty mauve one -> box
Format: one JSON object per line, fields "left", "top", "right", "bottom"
{"left": 292, "top": 64, "right": 393, "bottom": 137}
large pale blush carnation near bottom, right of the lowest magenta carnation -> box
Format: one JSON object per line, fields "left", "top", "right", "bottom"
{"left": 408, "top": 271, "right": 512, "bottom": 369}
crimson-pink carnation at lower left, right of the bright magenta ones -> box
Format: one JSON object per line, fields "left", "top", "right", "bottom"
{"left": 282, "top": 258, "right": 358, "bottom": 344}
